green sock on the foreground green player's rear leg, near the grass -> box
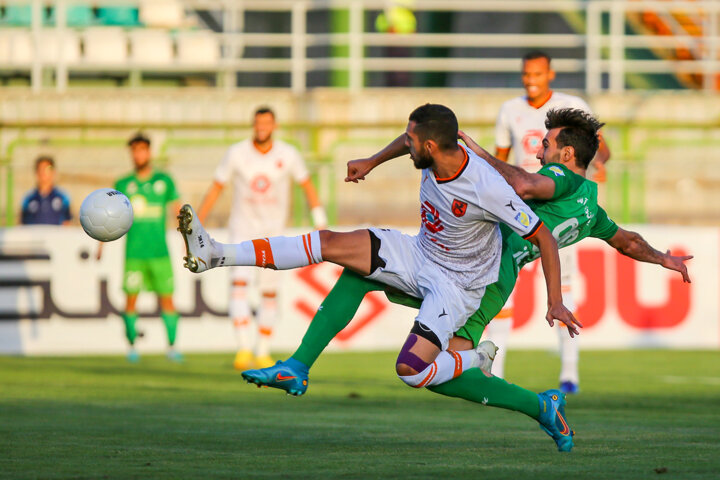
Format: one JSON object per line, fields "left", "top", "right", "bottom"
{"left": 428, "top": 368, "right": 540, "bottom": 420}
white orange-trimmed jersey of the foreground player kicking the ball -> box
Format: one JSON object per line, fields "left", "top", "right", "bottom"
{"left": 416, "top": 145, "right": 542, "bottom": 289}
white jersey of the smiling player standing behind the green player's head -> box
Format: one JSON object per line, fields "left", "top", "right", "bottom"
{"left": 495, "top": 92, "right": 592, "bottom": 172}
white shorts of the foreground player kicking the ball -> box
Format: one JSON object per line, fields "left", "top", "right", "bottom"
{"left": 367, "top": 228, "right": 485, "bottom": 350}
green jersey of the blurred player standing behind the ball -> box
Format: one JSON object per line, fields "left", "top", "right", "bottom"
{"left": 115, "top": 171, "right": 180, "bottom": 259}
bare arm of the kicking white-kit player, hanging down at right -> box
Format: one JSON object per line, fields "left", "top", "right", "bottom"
{"left": 528, "top": 225, "right": 582, "bottom": 337}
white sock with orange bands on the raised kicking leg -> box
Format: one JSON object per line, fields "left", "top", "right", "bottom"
{"left": 218, "top": 231, "right": 322, "bottom": 270}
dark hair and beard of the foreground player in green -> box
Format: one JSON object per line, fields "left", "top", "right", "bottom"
{"left": 545, "top": 108, "right": 605, "bottom": 168}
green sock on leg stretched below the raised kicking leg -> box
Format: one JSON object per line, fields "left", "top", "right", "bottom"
{"left": 291, "top": 269, "right": 385, "bottom": 368}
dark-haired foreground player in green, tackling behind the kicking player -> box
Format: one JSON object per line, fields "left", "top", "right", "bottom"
{"left": 243, "top": 109, "right": 692, "bottom": 451}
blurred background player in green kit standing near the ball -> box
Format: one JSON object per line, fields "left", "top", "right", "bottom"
{"left": 98, "top": 133, "right": 182, "bottom": 362}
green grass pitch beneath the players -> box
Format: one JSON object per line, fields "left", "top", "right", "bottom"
{"left": 0, "top": 351, "right": 720, "bottom": 480}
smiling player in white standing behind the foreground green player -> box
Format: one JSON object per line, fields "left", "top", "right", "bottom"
{"left": 487, "top": 51, "right": 610, "bottom": 393}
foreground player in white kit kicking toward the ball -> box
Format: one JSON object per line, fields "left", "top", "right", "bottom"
{"left": 178, "top": 104, "right": 582, "bottom": 401}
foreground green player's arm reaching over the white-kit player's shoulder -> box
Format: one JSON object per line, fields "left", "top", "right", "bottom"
{"left": 458, "top": 131, "right": 555, "bottom": 200}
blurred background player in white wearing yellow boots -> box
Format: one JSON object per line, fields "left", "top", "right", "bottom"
{"left": 198, "top": 107, "right": 327, "bottom": 370}
